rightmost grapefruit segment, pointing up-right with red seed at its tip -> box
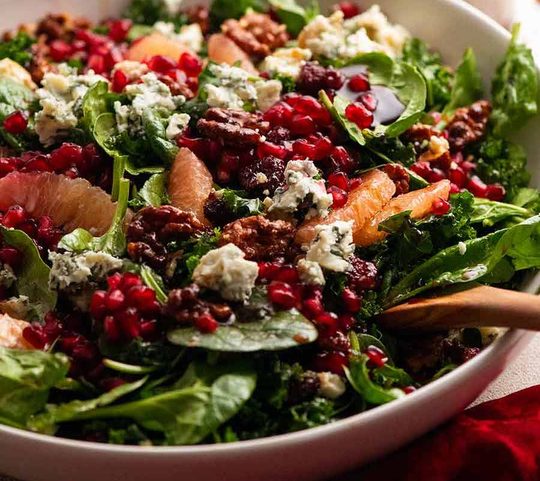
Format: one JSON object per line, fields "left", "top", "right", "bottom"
{"left": 354, "top": 180, "right": 450, "bottom": 247}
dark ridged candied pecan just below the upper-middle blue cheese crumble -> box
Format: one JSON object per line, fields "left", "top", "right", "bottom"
{"left": 197, "top": 107, "right": 269, "bottom": 145}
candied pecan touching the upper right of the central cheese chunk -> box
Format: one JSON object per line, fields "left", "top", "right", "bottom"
{"left": 219, "top": 215, "right": 295, "bottom": 261}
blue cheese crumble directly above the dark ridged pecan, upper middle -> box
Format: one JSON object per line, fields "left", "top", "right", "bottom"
{"left": 205, "top": 64, "right": 282, "bottom": 111}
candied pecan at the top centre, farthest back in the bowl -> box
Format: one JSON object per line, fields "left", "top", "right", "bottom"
{"left": 221, "top": 12, "right": 289, "bottom": 58}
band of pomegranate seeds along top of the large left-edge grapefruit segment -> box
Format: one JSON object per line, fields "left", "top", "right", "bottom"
{"left": 0, "top": 142, "right": 112, "bottom": 189}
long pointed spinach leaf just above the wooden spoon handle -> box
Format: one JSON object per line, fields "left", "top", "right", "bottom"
{"left": 385, "top": 215, "right": 540, "bottom": 306}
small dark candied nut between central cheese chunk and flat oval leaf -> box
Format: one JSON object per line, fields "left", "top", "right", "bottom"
{"left": 165, "top": 284, "right": 233, "bottom": 324}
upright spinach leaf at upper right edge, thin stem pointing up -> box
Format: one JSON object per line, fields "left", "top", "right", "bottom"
{"left": 491, "top": 25, "right": 538, "bottom": 137}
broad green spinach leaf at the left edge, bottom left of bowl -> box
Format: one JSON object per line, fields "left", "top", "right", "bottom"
{"left": 0, "top": 347, "right": 69, "bottom": 427}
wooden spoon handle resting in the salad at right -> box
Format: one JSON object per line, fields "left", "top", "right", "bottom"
{"left": 377, "top": 286, "right": 540, "bottom": 331}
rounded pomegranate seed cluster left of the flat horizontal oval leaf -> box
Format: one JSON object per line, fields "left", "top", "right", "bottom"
{"left": 90, "top": 272, "right": 161, "bottom": 343}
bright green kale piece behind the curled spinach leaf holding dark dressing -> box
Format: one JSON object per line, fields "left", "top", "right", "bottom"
{"left": 402, "top": 38, "right": 454, "bottom": 111}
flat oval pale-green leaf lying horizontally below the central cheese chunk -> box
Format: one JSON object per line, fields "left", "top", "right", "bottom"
{"left": 167, "top": 309, "right": 317, "bottom": 352}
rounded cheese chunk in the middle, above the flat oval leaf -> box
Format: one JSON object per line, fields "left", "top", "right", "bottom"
{"left": 193, "top": 244, "right": 259, "bottom": 301}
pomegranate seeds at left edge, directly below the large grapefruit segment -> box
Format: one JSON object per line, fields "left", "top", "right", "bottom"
{"left": 0, "top": 205, "right": 63, "bottom": 253}
